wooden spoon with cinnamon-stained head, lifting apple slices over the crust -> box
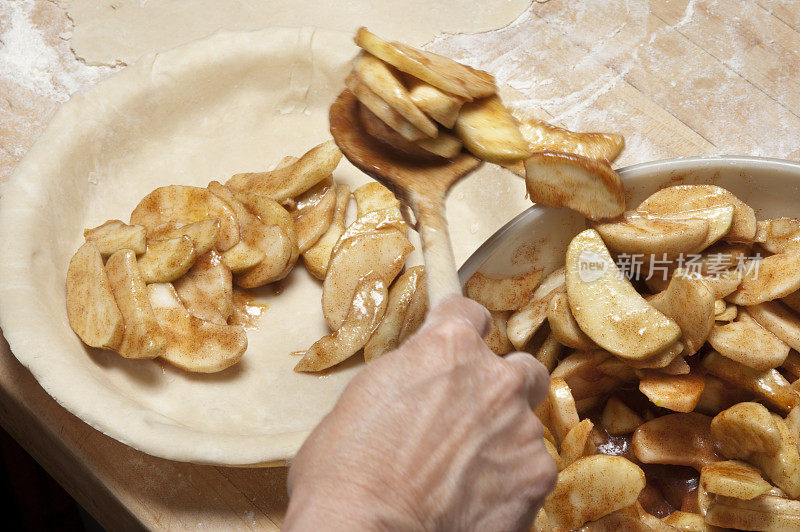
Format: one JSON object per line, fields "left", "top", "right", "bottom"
{"left": 330, "top": 90, "right": 481, "bottom": 308}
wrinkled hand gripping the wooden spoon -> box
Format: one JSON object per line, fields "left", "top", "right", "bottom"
{"left": 284, "top": 296, "right": 557, "bottom": 531}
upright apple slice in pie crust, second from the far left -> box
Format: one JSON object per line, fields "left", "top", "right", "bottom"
{"left": 106, "top": 249, "right": 167, "bottom": 358}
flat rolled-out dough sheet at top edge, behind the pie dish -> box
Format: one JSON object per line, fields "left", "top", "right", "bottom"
{"left": 58, "top": 0, "right": 531, "bottom": 65}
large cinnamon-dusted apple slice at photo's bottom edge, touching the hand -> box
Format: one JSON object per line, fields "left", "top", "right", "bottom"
{"left": 544, "top": 454, "right": 645, "bottom": 530}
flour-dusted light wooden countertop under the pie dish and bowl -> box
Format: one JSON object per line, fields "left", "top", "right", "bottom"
{"left": 0, "top": 0, "right": 800, "bottom": 530}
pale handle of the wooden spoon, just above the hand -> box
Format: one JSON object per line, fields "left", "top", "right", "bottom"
{"left": 413, "top": 193, "right": 461, "bottom": 308}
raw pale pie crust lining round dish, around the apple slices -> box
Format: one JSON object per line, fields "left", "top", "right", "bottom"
{"left": 0, "top": 28, "right": 527, "bottom": 465}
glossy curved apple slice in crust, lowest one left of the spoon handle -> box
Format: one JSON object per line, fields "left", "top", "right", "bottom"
{"left": 294, "top": 277, "right": 388, "bottom": 372}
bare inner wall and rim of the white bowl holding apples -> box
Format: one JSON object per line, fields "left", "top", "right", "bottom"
{"left": 459, "top": 156, "right": 800, "bottom": 284}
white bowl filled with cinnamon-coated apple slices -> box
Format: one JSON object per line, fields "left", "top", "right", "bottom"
{"left": 460, "top": 153, "right": 800, "bottom": 530}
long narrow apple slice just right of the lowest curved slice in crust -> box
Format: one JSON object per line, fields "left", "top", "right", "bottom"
{"left": 364, "top": 266, "right": 425, "bottom": 362}
